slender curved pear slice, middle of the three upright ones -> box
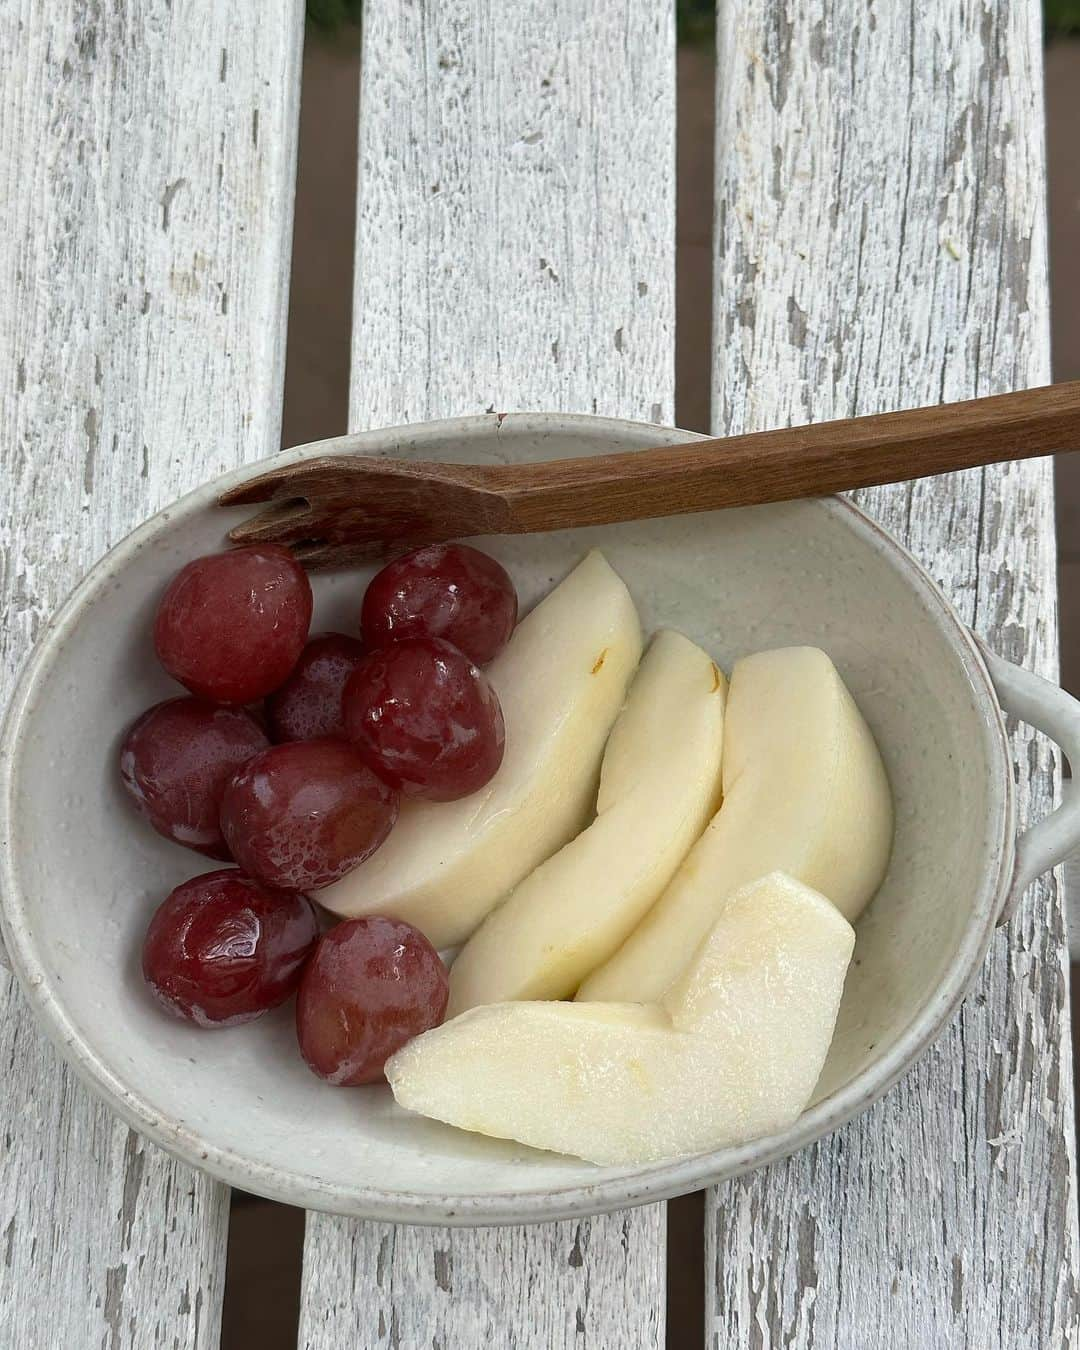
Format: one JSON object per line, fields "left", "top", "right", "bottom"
{"left": 447, "top": 632, "right": 728, "bottom": 1017}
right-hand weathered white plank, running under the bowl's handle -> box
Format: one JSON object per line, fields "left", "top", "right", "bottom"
{"left": 706, "top": 0, "right": 1080, "bottom": 1350}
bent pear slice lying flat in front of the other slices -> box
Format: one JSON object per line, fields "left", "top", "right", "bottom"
{"left": 386, "top": 873, "right": 855, "bottom": 1165}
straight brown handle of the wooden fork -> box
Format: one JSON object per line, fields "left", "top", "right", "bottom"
{"left": 488, "top": 381, "right": 1080, "bottom": 533}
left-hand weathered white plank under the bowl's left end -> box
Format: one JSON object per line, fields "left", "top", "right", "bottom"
{"left": 0, "top": 0, "right": 302, "bottom": 1350}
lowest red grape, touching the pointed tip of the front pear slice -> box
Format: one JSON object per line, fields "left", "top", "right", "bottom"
{"left": 296, "top": 914, "right": 450, "bottom": 1085}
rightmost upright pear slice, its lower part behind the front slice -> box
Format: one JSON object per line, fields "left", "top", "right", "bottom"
{"left": 578, "top": 647, "right": 892, "bottom": 1003}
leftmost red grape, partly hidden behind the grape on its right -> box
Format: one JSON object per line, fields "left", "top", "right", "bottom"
{"left": 120, "top": 698, "right": 270, "bottom": 859}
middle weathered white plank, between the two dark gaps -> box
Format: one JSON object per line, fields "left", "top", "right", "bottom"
{"left": 301, "top": 0, "right": 675, "bottom": 1350}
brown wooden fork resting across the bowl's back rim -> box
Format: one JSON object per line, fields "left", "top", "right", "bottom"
{"left": 220, "top": 381, "right": 1080, "bottom": 567}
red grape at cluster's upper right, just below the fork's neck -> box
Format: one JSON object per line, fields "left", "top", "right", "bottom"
{"left": 360, "top": 544, "right": 517, "bottom": 666}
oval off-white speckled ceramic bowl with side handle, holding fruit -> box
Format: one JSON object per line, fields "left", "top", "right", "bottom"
{"left": 0, "top": 414, "right": 1080, "bottom": 1223}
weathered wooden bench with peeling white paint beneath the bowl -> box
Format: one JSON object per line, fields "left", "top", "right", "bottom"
{"left": 0, "top": 0, "right": 1080, "bottom": 1350}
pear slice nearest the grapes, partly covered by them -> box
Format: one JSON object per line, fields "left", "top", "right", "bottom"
{"left": 316, "top": 552, "right": 641, "bottom": 946}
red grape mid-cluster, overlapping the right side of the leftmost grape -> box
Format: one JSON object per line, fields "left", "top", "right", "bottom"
{"left": 221, "top": 737, "right": 397, "bottom": 891}
